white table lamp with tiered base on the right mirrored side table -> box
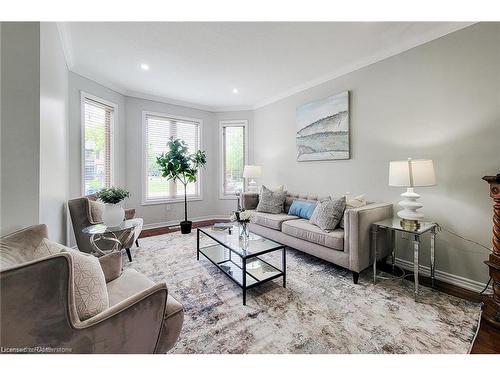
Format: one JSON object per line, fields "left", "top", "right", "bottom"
{"left": 389, "top": 158, "right": 436, "bottom": 229}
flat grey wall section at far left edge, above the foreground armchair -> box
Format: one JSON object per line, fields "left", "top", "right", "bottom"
{"left": 0, "top": 22, "right": 40, "bottom": 235}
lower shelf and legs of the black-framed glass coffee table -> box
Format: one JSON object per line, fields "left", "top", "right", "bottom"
{"left": 197, "top": 244, "right": 286, "bottom": 305}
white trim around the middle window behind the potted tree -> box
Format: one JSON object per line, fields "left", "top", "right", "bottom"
{"left": 141, "top": 111, "right": 204, "bottom": 206}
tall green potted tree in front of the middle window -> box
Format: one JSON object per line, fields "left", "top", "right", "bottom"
{"left": 156, "top": 137, "right": 207, "bottom": 234}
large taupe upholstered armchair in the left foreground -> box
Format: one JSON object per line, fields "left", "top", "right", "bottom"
{"left": 0, "top": 225, "right": 184, "bottom": 353}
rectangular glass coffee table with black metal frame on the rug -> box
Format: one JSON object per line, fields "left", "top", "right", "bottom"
{"left": 196, "top": 226, "right": 286, "bottom": 305}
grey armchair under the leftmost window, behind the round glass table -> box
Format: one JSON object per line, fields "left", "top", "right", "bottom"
{"left": 68, "top": 195, "right": 143, "bottom": 261}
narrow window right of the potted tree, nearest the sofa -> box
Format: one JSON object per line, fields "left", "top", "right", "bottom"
{"left": 220, "top": 120, "right": 248, "bottom": 198}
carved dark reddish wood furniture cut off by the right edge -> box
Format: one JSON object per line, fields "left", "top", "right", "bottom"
{"left": 483, "top": 173, "right": 500, "bottom": 328}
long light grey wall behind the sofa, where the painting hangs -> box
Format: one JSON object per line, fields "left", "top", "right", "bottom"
{"left": 252, "top": 23, "right": 500, "bottom": 282}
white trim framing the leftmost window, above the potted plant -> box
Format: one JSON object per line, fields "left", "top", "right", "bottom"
{"left": 80, "top": 91, "right": 119, "bottom": 196}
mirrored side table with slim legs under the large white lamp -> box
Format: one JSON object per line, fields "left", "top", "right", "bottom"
{"left": 370, "top": 217, "right": 439, "bottom": 301}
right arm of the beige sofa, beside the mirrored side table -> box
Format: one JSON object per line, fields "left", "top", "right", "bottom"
{"left": 344, "top": 203, "right": 393, "bottom": 272}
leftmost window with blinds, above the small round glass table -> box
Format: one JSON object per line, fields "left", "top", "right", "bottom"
{"left": 81, "top": 92, "right": 116, "bottom": 195}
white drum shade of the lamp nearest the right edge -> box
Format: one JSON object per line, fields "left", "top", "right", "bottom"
{"left": 389, "top": 159, "right": 436, "bottom": 187}
